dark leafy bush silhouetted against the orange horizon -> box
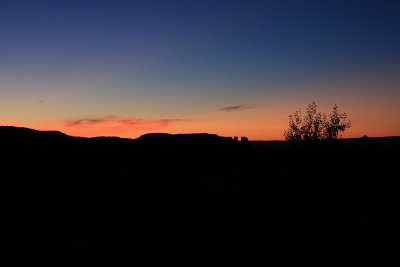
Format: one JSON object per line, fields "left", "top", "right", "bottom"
{"left": 284, "top": 101, "right": 351, "bottom": 141}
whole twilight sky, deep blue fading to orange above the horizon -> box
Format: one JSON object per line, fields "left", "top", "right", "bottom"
{"left": 0, "top": 0, "right": 400, "bottom": 140}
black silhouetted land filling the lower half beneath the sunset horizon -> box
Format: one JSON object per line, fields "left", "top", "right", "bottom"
{"left": 0, "top": 127, "right": 400, "bottom": 266}
